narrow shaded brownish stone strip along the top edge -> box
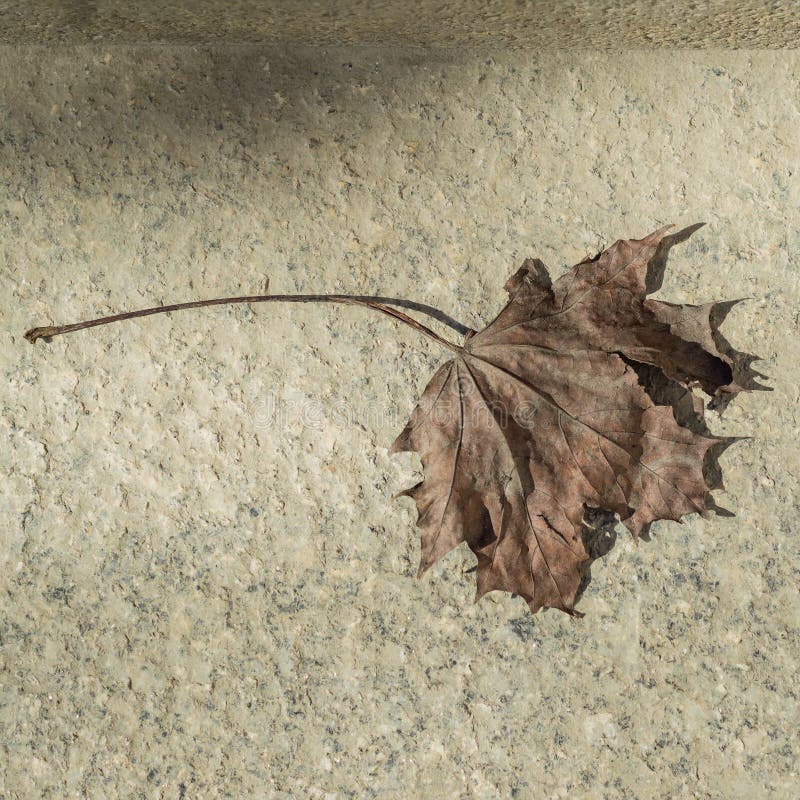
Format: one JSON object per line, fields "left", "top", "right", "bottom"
{"left": 0, "top": 0, "right": 800, "bottom": 52}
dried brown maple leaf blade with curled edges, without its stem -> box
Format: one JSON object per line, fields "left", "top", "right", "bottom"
{"left": 391, "top": 226, "right": 742, "bottom": 615}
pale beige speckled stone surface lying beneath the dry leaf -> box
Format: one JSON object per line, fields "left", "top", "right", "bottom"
{"left": 0, "top": 47, "right": 800, "bottom": 800}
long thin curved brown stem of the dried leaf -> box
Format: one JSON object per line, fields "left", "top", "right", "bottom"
{"left": 25, "top": 294, "right": 462, "bottom": 353}
